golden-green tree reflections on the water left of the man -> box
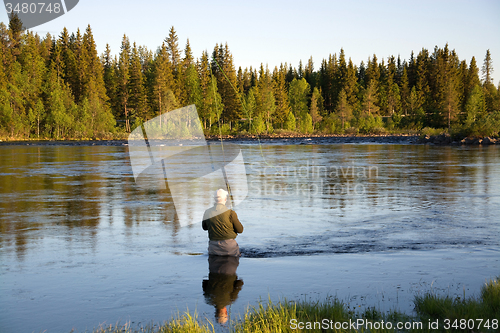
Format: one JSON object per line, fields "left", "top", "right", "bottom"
{"left": 0, "top": 146, "right": 185, "bottom": 257}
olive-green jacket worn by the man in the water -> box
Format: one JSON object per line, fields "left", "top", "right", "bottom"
{"left": 202, "top": 203, "right": 243, "bottom": 241}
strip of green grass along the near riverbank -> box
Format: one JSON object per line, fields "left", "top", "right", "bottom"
{"left": 79, "top": 278, "right": 500, "bottom": 333}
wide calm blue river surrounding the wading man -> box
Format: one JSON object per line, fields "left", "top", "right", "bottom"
{"left": 0, "top": 139, "right": 500, "bottom": 333}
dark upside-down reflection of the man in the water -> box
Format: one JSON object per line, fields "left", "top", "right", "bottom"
{"left": 203, "top": 256, "right": 243, "bottom": 324}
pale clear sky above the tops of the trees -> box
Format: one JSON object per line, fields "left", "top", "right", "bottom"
{"left": 0, "top": 0, "right": 500, "bottom": 85}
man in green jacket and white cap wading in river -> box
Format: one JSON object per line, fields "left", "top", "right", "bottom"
{"left": 202, "top": 189, "right": 243, "bottom": 257}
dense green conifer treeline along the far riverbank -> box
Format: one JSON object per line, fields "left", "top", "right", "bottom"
{"left": 0, "top": 17, "right": 500, "bottom": 138}
